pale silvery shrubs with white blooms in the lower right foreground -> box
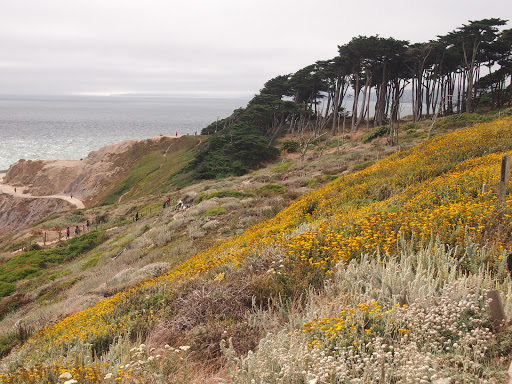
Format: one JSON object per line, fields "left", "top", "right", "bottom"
{"left": 223, "top": 246, "right": 508, "bottom": 384}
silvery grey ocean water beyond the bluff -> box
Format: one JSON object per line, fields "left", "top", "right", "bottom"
{"left": 0, "top": 96, "right": 249, "bottom": 170}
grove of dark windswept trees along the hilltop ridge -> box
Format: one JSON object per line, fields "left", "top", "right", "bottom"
{"left": 191, "top": 18, "right": 512, "bottom": 178}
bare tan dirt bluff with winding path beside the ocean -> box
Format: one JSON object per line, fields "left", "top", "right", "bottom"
{"left": 0, "top": 136, "right": 180, "bottom": 233}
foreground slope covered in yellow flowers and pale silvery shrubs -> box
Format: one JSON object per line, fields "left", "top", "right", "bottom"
{"left": 0, "top": 118, "right": 512, "bottom": 383}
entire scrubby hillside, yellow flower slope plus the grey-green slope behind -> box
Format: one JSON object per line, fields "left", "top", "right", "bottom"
{"left": 0, "top": 113, "right": 512, "bottom": 383}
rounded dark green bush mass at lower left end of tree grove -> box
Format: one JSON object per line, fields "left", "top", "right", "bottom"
{"left": 186, "top": 123, "right": 279, "bottom": 179}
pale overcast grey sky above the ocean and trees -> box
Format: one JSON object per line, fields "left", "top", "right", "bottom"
{"left": 0, "top": 0, "right": 512, "bottom": 96}
